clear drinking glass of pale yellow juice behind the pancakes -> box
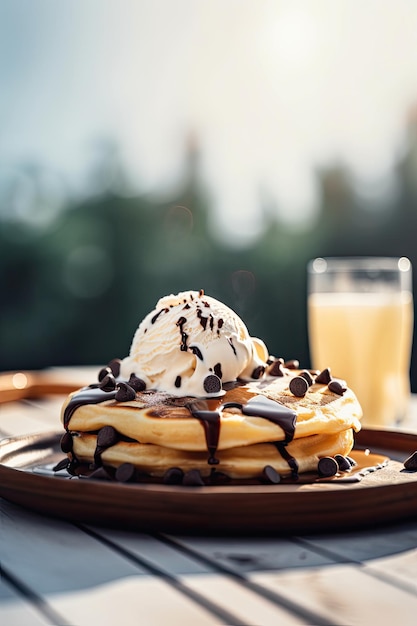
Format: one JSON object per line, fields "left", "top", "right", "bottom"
{"left": 308, "top": 257, "right": 413, "bottom": 427}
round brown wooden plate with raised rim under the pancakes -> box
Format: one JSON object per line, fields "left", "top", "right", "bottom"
{"left": 0, "top": 429, "right": 417, "bottom": 534}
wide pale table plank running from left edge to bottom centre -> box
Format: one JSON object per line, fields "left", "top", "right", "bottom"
{"left": 0, "top": 501, "right": 220, "bottom": 626}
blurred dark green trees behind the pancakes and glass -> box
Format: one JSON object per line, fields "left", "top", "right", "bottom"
{"left": 0, "top": 133, "right": 417, "bottom": 391}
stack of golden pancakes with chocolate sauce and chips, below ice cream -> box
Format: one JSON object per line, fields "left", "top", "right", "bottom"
{"left": 62, "top": 360, "right": 362, "bottom": 479}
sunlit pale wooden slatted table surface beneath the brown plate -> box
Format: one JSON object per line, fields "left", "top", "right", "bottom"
{"left": 0, "top": 368, "right": 417, "bottom": 626}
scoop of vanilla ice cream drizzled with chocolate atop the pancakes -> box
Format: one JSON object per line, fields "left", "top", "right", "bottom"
{"left": 120, "top": 291, "right": 268, "bottom": 397}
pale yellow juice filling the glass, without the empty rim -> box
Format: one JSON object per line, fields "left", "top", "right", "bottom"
{"left": 308, "top": 291, "right": 413, "bottom": 426}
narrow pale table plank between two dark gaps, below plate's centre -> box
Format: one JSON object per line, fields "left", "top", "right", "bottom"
{"left": 96, "top": 529, "right": 305, "bottom": 626}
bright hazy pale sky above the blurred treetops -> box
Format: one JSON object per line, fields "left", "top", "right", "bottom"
{"left": 0, "top": 0, "right": 417, "bottom": 242}
